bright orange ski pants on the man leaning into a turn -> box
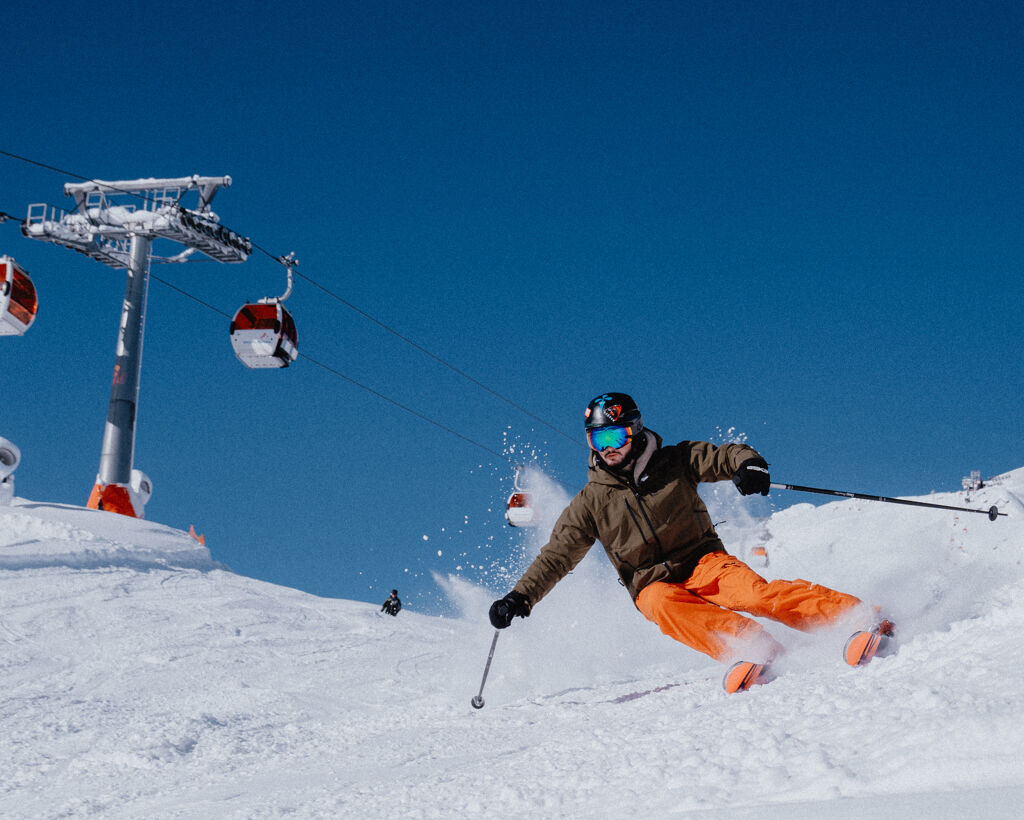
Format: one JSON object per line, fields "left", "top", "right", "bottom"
{"left": 636, "top": 552, "right": 860, "bottom": 662}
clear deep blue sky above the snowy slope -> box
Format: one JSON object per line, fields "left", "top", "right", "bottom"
{"left": 0, "top": 1, "right": 1024, "bottom": 610}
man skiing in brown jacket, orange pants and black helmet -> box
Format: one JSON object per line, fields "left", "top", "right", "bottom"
{"left": 488, "top": 393, "right": 893, "bottom": 692}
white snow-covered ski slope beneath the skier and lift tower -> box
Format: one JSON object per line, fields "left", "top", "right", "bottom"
{"left": 0, "top": 469, "right": 1024, "bottom": 818}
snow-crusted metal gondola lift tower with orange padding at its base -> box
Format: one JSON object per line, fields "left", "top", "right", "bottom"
{"left": 22, "top": 175, "right": 252, "bottom": 518}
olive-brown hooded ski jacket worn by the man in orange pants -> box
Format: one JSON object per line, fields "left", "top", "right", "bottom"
{"left": 515, "top": 430, "right": 760, "bottom": 606}
